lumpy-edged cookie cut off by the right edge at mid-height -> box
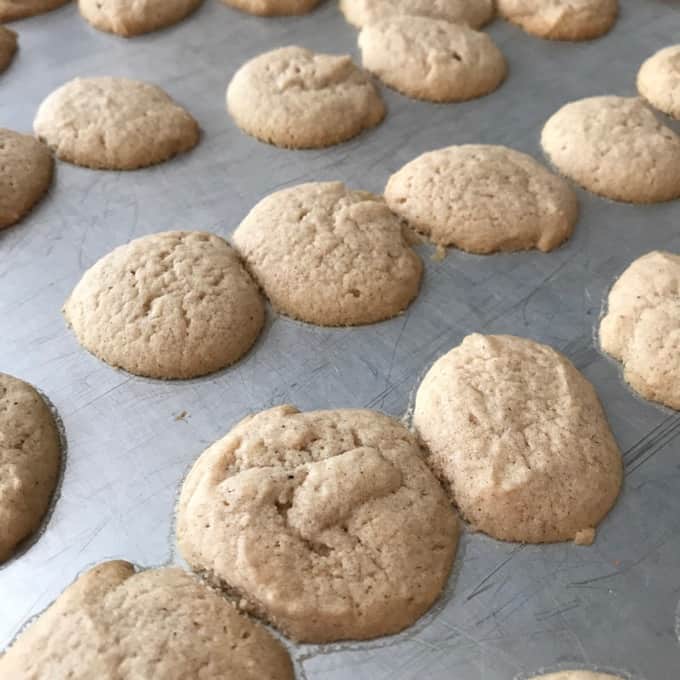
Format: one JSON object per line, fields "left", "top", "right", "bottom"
{"left": 600, "top": 251, "right": 680, "bottom": 410}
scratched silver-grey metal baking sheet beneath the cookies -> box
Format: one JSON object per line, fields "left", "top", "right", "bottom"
{"left": 0, "top": 0, "right": 680, "bottom": 680}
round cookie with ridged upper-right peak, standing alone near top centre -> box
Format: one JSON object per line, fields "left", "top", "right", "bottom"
{"left": 227, "top": 47, "right": 385, "bottom": 149}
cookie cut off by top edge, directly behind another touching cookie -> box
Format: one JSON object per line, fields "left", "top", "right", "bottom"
{"left": 340, "top": 0, "right": 495, "bottom": 28}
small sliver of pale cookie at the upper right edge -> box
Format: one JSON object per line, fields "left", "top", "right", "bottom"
{"left": 637, "top": 45, "right": 680, "bottom": 119}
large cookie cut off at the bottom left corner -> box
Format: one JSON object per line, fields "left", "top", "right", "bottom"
{"left": 0, "top": 561, "right": 293, "bottom": 680}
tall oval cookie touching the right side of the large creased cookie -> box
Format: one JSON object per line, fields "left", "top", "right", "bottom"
{"left": 413, "top": 333, "right": 622, "bottom": 543}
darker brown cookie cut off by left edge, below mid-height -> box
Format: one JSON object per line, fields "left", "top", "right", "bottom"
{"left": 0, "top": 373, "right": 61, "bottom": 564}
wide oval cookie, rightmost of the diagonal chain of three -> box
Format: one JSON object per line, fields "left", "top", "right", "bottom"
{"left": 385, "top": 144, "right": 579, "bottom": 253}
